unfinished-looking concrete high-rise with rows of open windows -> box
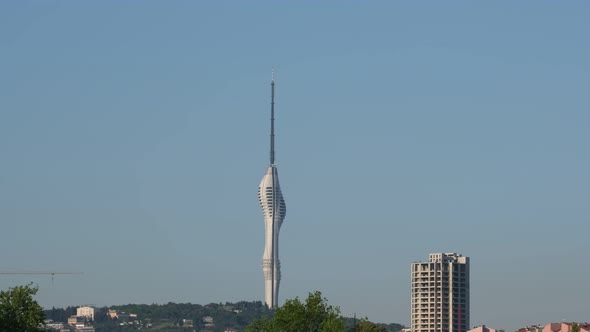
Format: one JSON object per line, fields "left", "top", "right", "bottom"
{"left": 411, "top": 253, "right": 469, "bottom": 332}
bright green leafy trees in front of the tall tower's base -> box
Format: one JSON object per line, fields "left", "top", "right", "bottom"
{"left": 246, "top": 291, "right": 346, "bottom": 332}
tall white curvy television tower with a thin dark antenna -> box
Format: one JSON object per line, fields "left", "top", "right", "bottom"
{"left": 258, "top": 69, "right": 287, "bottom": 308}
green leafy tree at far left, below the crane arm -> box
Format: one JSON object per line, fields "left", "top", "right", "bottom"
{"left": 0, "top": 283, "right": 44, "bottom": 332}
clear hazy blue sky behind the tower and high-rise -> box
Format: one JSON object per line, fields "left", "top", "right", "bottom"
{"left": 0, "top": 1, "right": 590, "bottom": 330}
